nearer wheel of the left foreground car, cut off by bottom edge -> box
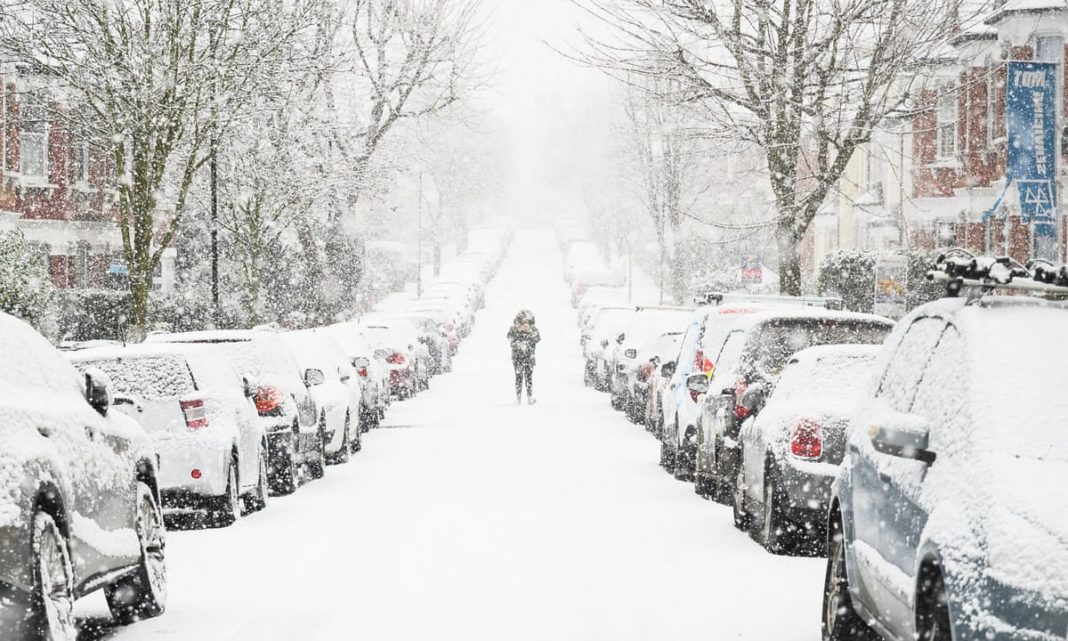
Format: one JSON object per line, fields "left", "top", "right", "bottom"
{"left": 25, "top": 511, "right": 78, "bottom": 641}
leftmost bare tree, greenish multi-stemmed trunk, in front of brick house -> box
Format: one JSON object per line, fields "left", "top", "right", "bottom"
{"left": 0, "top": 0, "right": 318, "bottom": 333}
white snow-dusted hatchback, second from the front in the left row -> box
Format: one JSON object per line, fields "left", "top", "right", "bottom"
{"left": 68, "top": 344, "right": 270, "bottom": 527}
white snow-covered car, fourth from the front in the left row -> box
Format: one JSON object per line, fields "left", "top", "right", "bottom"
{"left": 279, "top": 329, "right": 362, "bottom": 465}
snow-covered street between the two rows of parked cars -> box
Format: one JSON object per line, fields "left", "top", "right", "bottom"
{"left": 78, "top": 231, "right": 824, "bottom": 641}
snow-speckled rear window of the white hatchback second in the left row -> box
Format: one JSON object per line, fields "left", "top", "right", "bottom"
{"left": 76, "top": 356, "right": 197, "bottom": 401}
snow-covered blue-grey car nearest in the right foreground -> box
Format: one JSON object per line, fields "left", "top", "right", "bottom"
{"left": 823, "top": 294, "right": 1068, "bottom": 641}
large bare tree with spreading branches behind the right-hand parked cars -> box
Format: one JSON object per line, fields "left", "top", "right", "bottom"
{"left": 574, "top": 0, "right": 974, "bottom": 295}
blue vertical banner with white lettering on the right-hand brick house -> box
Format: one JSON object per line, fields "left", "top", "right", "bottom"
{"left": 1005, "top": 60, "right": 1057, "bottom": 240}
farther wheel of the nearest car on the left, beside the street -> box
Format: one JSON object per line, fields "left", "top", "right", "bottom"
{"left": 104, "top": 482, "right": 167, "bottom": 625}
